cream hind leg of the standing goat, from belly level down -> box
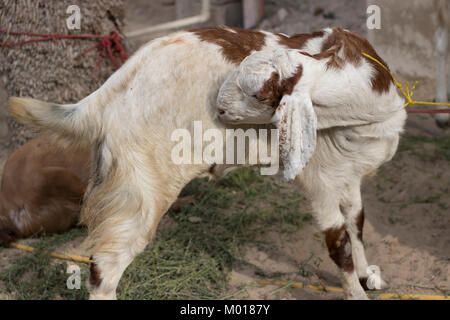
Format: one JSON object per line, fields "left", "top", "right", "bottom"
{"left": 84, "top": 180, "right": 176, "bottom": 299}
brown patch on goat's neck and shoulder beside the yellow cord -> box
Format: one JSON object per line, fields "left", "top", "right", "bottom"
{"left": 313, "top": 28, "right": 393, "bottom": 93}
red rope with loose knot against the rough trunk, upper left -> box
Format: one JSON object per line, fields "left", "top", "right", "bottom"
{"left": 0, "top": 29, "right": 128, "bottom": 72}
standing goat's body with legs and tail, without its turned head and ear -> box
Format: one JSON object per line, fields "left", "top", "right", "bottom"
{"left": 9, "top": 27, "right": 406, "bottom": 299}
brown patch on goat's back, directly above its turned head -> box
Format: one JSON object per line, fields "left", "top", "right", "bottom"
{"left": 189, "top": 27, "right": 266, "bottom": 65}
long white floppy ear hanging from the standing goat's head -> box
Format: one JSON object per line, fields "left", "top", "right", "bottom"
{"left": 272, "top": 91, "right": 317, "bottom": 180}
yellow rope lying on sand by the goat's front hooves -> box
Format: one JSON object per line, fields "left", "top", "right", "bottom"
{"left": 256, "top": 280, "right": 450, "bottom": 300}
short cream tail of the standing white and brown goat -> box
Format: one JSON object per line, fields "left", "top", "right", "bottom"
{"left": 8, "top": 97, "right": 100, "bottom": 144}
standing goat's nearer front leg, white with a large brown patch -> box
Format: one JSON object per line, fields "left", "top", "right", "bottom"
{"left": 312, "top": 195, "right": 367, "bottom": 300}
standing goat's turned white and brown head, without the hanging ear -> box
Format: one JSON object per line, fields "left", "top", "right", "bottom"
{"left": 217, "top": 49, "right": 302, "bottom": 124}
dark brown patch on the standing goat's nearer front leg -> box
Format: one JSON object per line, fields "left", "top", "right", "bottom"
{"left": 325, "top": 226, "right": 354, "bottom": 272}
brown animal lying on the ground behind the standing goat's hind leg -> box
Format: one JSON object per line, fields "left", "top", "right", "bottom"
{"left": 0, "top": 136, "right": 90, "bottom": 244}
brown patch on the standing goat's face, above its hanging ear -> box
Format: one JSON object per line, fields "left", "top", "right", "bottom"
{"left": 256, "top": 65, "right": 303, "bottom": 109}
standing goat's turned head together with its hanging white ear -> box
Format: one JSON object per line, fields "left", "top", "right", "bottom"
{"left": 217, "top": 49, "right": 317, "bottom": 179}
